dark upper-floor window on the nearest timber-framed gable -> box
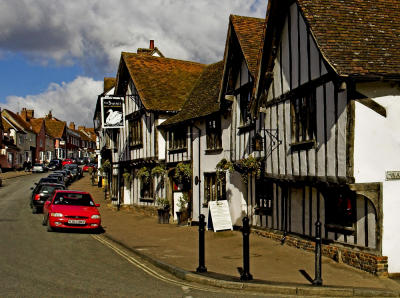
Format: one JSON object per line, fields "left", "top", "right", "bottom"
{"left": 291, "top": 92, "right": 316, "bottom": 143}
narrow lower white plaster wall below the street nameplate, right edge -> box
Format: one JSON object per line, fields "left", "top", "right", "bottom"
{"left": 382, "top": 181, "right": 400, "bottom": 273}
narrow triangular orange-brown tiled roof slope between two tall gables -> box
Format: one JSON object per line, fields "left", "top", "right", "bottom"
{"left": 230, "top": 15, "right": 265, "bottom": 76}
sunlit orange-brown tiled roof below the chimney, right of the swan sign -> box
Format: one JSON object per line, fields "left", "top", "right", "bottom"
{"left": 122, "top": 52, "right": 206, "bottom": 111}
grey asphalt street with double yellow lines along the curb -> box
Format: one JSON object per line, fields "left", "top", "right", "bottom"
{"left": 0, "top": 174, "right": 270, "bottom": 297}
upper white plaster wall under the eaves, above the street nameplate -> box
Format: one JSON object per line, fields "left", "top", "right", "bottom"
{"left": 354, "top": 84, "right": 400, "bottom": 183}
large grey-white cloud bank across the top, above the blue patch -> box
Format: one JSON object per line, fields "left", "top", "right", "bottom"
{"left": 0, "top": 0, "right": 267, "bottom": 72}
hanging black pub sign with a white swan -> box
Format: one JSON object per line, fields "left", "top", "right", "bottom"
{"left": 101, "top": 96, "right": 125, "bottom": 128}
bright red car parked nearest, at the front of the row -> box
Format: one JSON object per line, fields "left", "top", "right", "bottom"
{"left": 43, "top": 190, "right": 101, "bottom": 232}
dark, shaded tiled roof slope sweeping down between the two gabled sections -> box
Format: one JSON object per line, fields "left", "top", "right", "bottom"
{"left": 161, "top": 61, "right": 224, "bottom": 127}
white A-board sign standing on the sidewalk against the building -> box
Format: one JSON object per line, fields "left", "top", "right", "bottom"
{"left": 208, "top": 200, "right": 233, "bottom": 232}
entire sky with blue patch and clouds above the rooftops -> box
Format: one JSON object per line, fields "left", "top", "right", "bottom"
{"left": 0, "top": 0, "right": 267, "bottom": 127}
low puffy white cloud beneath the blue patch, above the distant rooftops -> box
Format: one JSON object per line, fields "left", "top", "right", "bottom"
{"left": 2, "top": 77, "right": 103, "bottom": 127}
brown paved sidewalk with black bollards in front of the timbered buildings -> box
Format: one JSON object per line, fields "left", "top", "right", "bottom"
{"left": 69, "top": 175, "right": 400, "bottom": 297}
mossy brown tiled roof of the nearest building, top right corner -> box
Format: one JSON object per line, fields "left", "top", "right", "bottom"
{"left": 297, "top": 0, "right": 400, "bottom": 76}
